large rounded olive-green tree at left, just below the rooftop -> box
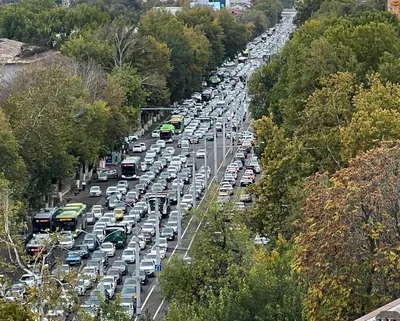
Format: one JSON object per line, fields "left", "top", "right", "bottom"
{"left": 3, "top": 66, "right": 102, "bottom": 205}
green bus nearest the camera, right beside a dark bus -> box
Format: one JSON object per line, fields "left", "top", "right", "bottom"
{"left": 56, "top": 203, "right": 86, "bottom": 237}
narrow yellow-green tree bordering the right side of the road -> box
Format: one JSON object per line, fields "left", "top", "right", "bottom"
{"left": 249, "top": 116, "right": 313, "bottom": 242}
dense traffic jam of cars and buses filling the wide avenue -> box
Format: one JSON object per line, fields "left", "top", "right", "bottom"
{"left": 0, "top": 16, "right": 291, "bottom": 319}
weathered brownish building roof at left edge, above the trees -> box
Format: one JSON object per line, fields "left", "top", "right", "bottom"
{"left": 0, "top": 38, "right": 60, "bottom": 65}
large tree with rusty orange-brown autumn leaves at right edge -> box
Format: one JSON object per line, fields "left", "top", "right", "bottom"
{"left": 296, "top": 142, "right": 400, "bottom": 321}
